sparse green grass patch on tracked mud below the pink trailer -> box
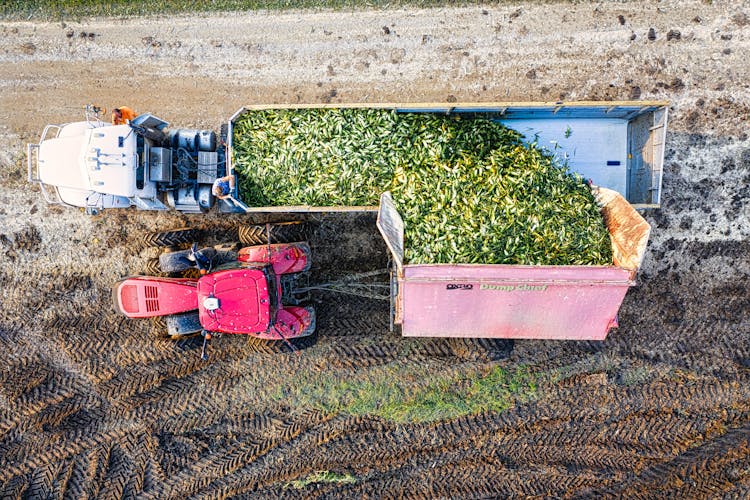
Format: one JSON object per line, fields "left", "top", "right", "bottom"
{"left": 274, "top": 364, "right": 537, "bottom": 423}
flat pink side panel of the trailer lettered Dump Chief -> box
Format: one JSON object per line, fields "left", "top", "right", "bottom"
{"left": 399, "top": 265, "right": 632, "bottom": 340}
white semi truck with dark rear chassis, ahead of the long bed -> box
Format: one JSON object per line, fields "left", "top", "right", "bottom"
{"left": 27, "top": 106, "right": 225, "bottom": 214}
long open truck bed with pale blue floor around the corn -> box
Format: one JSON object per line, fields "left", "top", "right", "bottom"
{"left": 228, "top": 101, "right": 667, "bottom": 213}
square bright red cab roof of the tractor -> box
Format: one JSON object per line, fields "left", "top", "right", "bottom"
{"left": 198, "top": 268, "right": 271, "bottom": 333}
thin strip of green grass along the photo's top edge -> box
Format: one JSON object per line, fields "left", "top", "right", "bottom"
{"left": 0, "top": 0, "right": 508, "bottom": 20}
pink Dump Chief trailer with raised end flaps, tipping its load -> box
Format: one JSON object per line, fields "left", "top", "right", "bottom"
{"left": 377, "top": 188, "right": 651, "bottom": 340}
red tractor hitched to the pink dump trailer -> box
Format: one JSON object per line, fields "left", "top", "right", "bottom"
{"left": 114, "top": 236, "right": 315, "bottom": 359}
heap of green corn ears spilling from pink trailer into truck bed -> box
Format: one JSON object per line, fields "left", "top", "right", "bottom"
{"left": 233, "top": 109, "right": 612, "bottom": 265}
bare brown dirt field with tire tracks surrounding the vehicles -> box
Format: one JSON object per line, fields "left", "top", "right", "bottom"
{"left": 0, "top": 0, "right": 750, "bottom": 498}
